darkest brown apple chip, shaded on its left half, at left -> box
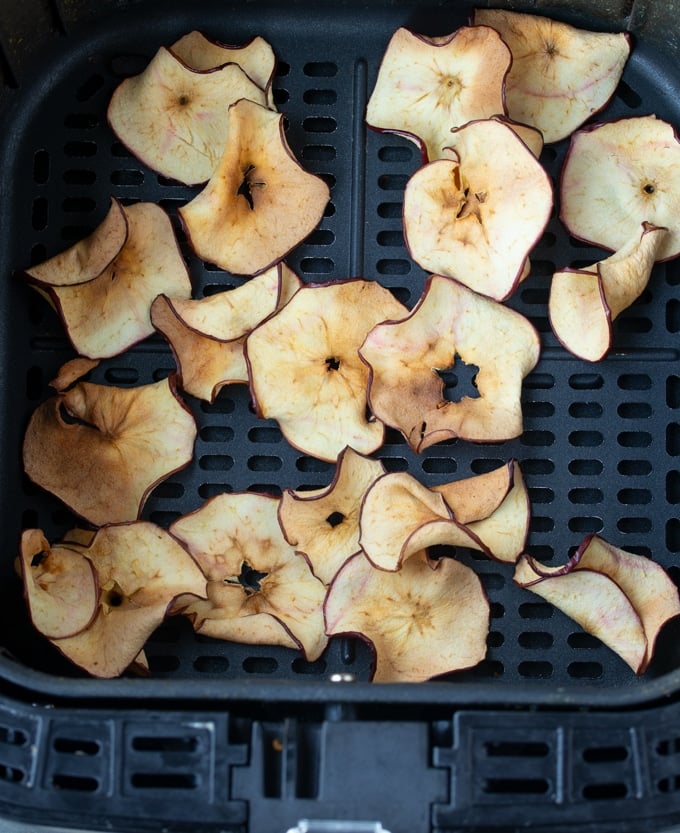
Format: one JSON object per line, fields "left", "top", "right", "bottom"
{"left": 23, "top": 379, "right": 196, "bottom": 526}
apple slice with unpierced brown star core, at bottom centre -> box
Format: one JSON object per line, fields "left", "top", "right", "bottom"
{"left": 324, "top": 552, "right": 489, "bottom": 683}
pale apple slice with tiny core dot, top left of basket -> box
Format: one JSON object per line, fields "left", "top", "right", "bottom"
{"left": 107, "top": 47, "right": 267, "bottom": 185}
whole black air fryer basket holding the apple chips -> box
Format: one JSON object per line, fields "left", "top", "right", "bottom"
{"left": 0, "top": 0, "right": 680, "bottom": 833}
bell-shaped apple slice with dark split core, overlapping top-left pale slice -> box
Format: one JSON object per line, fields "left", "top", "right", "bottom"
{"left": 178, "top": 99, "right": 330, "bottom": 275}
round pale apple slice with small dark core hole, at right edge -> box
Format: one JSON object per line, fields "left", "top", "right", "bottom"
{"left": 560, "top": 116, "right": 680, "bottom": 260}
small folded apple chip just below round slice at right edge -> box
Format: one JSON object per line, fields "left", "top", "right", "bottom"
{"left": 548, "top": 223, "right": 668, "bottom": 362}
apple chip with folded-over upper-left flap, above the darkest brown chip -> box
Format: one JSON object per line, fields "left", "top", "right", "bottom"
{"left": 24, "top": 199, "right": 191, "bottom": 359}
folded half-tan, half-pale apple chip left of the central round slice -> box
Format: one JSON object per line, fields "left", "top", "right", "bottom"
{"left": 151, "top": 262, "right": 302, "bottom": 402}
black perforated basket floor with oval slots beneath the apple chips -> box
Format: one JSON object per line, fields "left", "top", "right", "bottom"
{"left": 0, "top": 2, "right": 680, "bottom": 702}
